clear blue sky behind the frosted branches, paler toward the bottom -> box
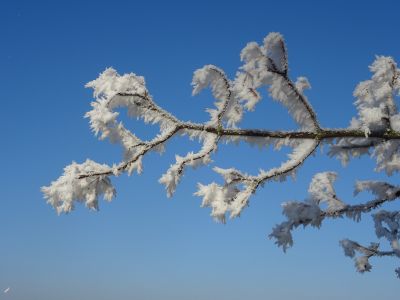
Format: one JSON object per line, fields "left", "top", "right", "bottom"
{"left": 0, "top": 0, "right": 400, "bottom": 300}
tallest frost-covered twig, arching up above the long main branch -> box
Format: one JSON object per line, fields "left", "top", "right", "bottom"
{"left": 236, "top": 33, "right": 320, "bottom": 131}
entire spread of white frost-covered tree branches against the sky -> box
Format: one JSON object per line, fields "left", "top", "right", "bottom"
{"left": 42, "top": 33, "right": 400, "bottom": 277}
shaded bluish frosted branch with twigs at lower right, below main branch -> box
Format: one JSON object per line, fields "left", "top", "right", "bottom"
{"left": 269, "top": 172, "right": 400, "bottom": 273}
